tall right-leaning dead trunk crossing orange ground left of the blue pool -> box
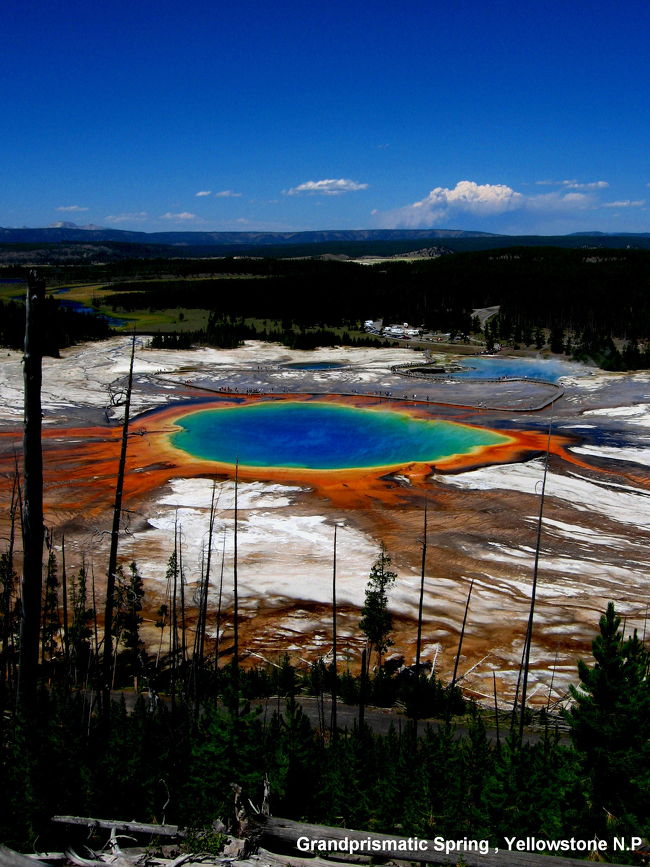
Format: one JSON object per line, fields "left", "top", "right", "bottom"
{"left": 102, "top": 334, "right": 135, "bottom": 719}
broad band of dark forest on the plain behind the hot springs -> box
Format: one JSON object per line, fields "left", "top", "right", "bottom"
{"left": 97, "top": 248, "right": 650, "bottom": 370}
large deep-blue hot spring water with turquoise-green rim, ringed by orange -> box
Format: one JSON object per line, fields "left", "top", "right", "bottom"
{"left": 171, "top": 401, "right": 508, "bottom": 470}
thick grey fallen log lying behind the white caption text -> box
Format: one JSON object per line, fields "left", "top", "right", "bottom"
{"left": 255, "top": 815, "right": 628, "bottom": 867}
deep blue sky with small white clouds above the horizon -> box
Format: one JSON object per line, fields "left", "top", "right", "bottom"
{"left": 5, "top": 0, "right": 650, "bottom": 234}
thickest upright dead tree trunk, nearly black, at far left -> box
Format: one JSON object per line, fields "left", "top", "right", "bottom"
{"left": 18, "top": 271, "right": 45, "bottom": 704}
